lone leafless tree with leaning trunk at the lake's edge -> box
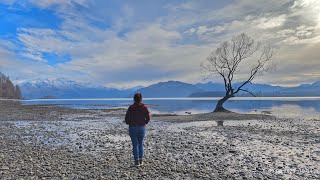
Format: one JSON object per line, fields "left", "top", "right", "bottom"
{"left": 201, "top": 33, "right": 275, "bottom": 112}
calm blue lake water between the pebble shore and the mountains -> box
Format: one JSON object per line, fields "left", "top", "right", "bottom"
{"left": 21, "top": 97, "right": 320, "bottom": 119}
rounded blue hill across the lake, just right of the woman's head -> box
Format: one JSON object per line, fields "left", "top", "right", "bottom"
{"left": 130, "top": 81, "right": 203, "bottom": 98}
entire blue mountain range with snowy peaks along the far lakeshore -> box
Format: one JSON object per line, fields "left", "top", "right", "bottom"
{"left": 15, "top": 78, "right": 320, "bottom": 99}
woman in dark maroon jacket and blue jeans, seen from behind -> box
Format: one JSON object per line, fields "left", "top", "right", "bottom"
{"left": 125, "top": 93, "right": 150, "bottom": 166}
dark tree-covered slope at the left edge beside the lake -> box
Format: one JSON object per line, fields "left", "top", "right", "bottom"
{"left": 0, "top": 73, "right": 22, "bottom": 99}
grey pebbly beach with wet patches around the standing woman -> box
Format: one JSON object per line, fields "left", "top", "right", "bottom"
{"left": 0, "top": 100, "right": 320, "bottom": 179}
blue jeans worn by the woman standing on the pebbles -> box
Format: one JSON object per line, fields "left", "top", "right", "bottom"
{"left": 129, "top": 126, "right": 146, "bottom": 160}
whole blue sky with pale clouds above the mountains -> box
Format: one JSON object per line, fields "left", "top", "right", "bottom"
{"left": 0, "top": 0, "right": 320, "bottom": 88}
